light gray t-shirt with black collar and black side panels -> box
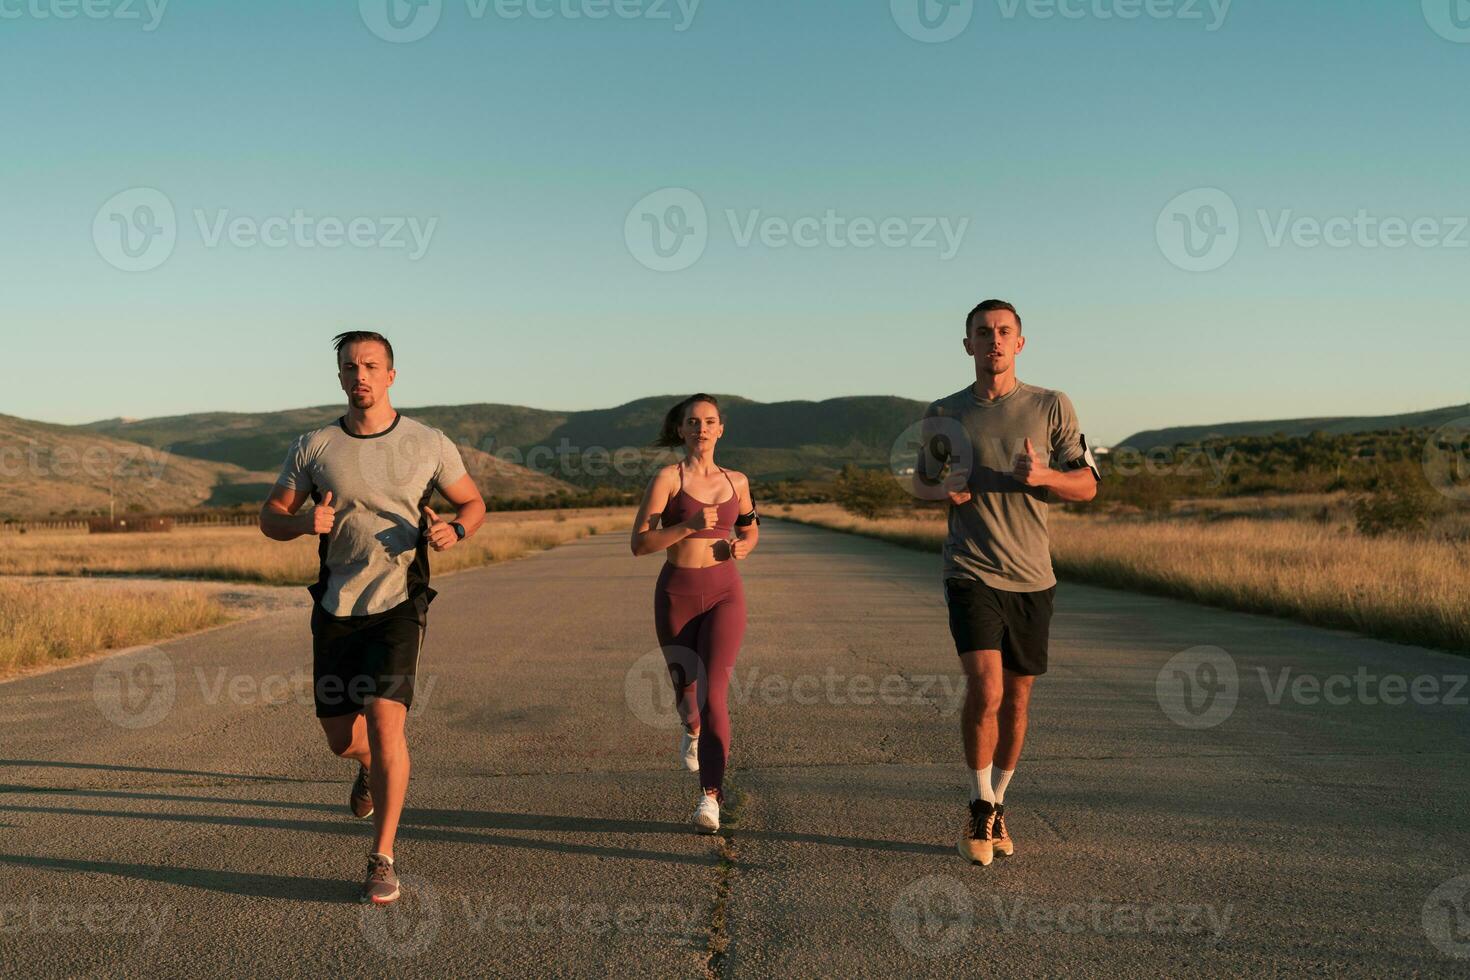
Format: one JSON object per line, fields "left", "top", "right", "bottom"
{"left": 276, "top": 414, "right": 465, "bottom": 617}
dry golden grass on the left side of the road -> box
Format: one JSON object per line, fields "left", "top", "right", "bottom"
{"left": 0, "top": 508, "right": 632, "bottom": 679}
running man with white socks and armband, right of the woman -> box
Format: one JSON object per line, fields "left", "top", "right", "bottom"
{"left": 914, "top": 300, "right": 1101, "bottom": 864}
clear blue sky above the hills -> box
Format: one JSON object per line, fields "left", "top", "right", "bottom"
{"left": 0, "top": 0, "right": 1470, "bottom": 444}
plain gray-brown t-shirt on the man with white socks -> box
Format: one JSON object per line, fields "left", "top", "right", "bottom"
{"left": 914, "top": 383, "right": 1095, "bottom": 592}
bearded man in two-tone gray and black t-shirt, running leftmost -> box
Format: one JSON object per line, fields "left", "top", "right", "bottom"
{"left": 260, "top": 332, "right": 485, "bottom": 905}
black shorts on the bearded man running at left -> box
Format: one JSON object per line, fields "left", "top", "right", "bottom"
{"left": 312, "top": 598, "right": 428, "bottom": 718}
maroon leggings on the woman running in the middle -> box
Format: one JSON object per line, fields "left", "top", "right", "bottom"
{"left": 653, "top": 560, "right": 745, "bottom": 799}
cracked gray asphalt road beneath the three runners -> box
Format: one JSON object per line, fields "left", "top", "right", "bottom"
{"left": 0, "top": 522, "right": 1470, "bottom": 977}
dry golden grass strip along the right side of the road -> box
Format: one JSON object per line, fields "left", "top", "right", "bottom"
{"left": 776, "top": 504, "right": 1470, "bottom": 652}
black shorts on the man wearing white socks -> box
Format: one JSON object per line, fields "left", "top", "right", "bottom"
{"left": 944, "top": 579, "right": 1057, "bottom": 674}
